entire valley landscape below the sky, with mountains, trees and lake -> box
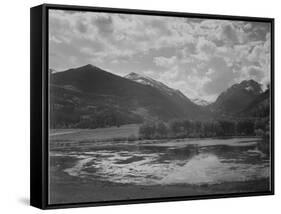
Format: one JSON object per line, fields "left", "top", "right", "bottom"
{"left": 49, "top": 65, "right": 271, "bottom": 204}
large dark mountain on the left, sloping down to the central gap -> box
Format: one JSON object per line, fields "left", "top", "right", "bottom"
{"left": 50, "top": 65, "right": 202, "bottom": 128}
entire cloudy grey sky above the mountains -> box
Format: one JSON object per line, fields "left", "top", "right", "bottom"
{"left": 49, "top": 10, "right": 271, "bottom": 101}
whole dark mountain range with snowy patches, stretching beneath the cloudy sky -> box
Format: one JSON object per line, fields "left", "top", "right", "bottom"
{"left": 50, "top": 65, "right": 268, "bottom": 128}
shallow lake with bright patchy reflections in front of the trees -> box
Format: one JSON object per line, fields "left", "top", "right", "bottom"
{"left": 52, "top": 138, "right": 270, "bottom": 185}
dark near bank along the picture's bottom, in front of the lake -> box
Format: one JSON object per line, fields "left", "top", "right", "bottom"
{"left": 50, "top": 171, "right": 270, "bottom": 204}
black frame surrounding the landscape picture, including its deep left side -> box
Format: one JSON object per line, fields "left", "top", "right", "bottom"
{"left": 30, "top": 4, "right": 274, "bottom": 209}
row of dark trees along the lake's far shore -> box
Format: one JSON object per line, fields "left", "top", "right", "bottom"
{"left": 139, "top": 118, "right": 269, "bottom": 139}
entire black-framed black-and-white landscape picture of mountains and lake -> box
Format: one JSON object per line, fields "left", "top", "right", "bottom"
{"left": 30, "top": 4, "right": 274, "bottom": 209}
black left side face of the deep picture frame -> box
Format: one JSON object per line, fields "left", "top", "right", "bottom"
{"left": 30, "top": 5, "right": 46, "bottom": 209}
